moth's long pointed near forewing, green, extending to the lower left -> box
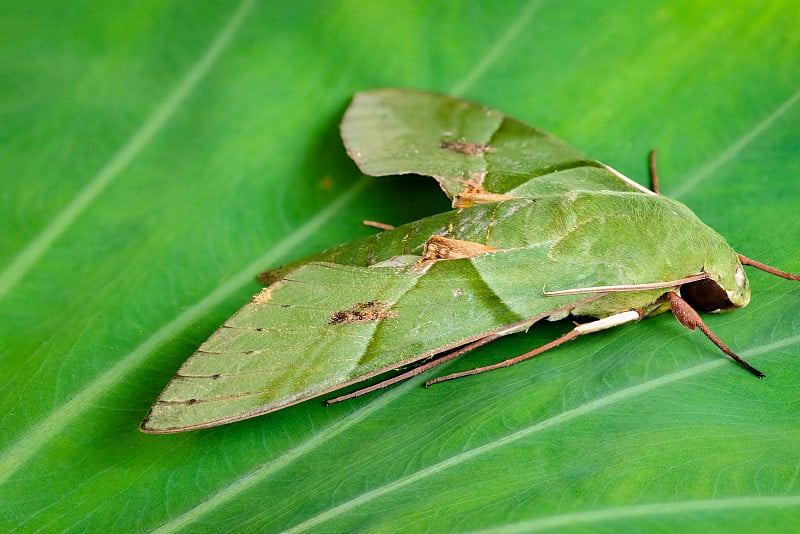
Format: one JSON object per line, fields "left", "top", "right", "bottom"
{"left": 142, "top": 255, "right": 568, "bottom": 433}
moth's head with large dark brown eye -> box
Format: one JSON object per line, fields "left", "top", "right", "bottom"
{"left": 681, "top": 257, "right": 750, "bottom": 313}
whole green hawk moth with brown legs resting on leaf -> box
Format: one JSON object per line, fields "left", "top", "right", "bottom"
{"left": 141, "top": 89, "right": 800, "bottom": 433}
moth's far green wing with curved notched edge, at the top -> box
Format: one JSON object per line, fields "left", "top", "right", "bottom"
{"left": 341, "top": 89, "right": 646, "bottom": 207}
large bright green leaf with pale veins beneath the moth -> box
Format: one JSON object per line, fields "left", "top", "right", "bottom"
{"left": 0, "top": 0, "right": 800, "bottom": 532}
